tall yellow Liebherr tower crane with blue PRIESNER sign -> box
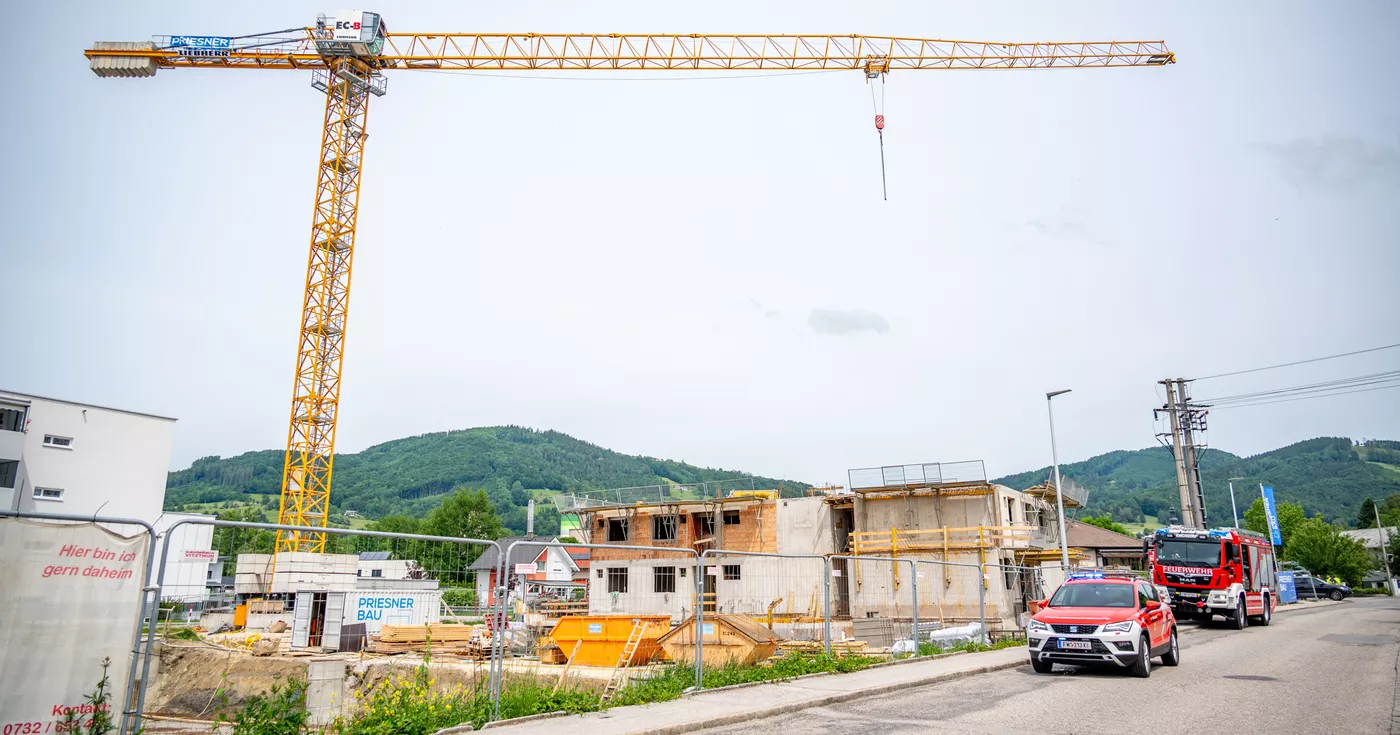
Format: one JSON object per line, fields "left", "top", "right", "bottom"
{"left": 84, "top": 10, "right": 1176, "bottom": 552}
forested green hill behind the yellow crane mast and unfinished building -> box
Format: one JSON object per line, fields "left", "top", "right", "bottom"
{"left": 165, "top": 426, "right": 809, "bottom": 533}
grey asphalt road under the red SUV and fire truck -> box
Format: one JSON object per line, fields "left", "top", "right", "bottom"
{"left": 704, "top": 598, "right": 1400, "bottom": 735}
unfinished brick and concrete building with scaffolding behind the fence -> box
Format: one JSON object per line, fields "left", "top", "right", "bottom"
{"left": 556, "top": 462, "right": 1085, "bottom": 630}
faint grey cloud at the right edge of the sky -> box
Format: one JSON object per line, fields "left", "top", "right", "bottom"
{"left": 1260, "top": 136, "right": 1400, "bottom": 192}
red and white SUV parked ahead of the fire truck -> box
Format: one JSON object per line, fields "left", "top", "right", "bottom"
{"left": 1026, "top": 573, "right": 1182, "bottom": 678}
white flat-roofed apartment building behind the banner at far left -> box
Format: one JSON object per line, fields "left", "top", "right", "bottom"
{"left": 0, "top": 391, "right": 175, "bottom": 522}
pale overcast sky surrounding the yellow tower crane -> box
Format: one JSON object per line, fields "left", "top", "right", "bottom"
{"left": 0, "top": 1, "right": 1400, "bottom": 483}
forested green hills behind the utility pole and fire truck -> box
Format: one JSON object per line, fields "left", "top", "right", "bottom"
{"left": 995, "top": 437, "right": 1400, "bottom": 525}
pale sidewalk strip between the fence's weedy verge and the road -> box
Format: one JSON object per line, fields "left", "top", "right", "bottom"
{"left": 487, "top": 648, "right": 1029, "bottom": 735}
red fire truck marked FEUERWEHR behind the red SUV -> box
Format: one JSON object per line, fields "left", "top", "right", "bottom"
{"left": 1145, "top": 526, "right": 1278, "bottom": 630}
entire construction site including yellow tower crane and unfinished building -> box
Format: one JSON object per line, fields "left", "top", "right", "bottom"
{"left": 0, "top": 10, "right": 1176, "bottom": 735}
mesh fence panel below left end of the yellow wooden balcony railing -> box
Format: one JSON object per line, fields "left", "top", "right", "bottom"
{"left": 830, "top": 554, "right": 921, "bottom": 652}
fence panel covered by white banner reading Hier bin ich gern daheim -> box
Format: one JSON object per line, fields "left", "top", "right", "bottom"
{"left": 0, "top": 511, "right": 157, "bottom": 732}
